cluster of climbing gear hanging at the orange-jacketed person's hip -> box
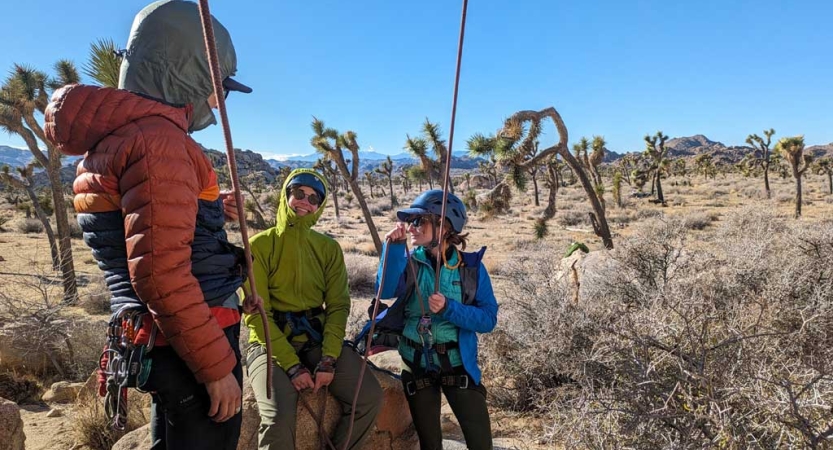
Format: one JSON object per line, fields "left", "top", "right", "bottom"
{"left": 99, "top": 304, "right": 156, "bottom": 431}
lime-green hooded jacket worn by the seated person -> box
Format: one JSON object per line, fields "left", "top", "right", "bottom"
{"left": 243, "top": 169, "right": 350, "bottom": 370}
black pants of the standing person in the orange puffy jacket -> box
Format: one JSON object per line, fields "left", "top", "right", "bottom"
{"left": 142, "top": 323, "right": 243, "bottom": 450}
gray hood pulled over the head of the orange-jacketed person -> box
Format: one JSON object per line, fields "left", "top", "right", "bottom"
{"left": 119, "top": 0, "right": 237, "bottom": 132}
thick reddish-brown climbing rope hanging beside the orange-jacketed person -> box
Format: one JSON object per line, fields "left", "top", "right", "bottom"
{"left": 199, "top": 0, "right": 272, "bottom": 399}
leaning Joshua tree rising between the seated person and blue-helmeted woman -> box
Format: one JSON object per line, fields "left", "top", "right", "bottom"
{"left": 310, "top": 117, "right": 382, "bottom": 254}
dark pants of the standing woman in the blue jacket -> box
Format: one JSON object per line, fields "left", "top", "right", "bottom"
{"left": 402, "top": 364, "right": 492, "bottom": 450}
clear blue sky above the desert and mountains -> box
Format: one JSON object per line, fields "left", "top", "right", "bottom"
{"left": 0, "top": 0, "right": 833, "bottom": 160}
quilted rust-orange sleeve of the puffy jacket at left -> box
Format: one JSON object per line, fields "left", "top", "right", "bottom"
{"left": 116, "top": 126, "right": 237, "bottom": 383}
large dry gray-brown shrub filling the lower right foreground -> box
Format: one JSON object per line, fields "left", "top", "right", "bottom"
{"left": 483, "top": 214, "right": 833, "bottom": 448}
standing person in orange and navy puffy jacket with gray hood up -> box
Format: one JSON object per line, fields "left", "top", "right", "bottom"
{"left": 45, "top": 0, "right": 251, "bottom": 449}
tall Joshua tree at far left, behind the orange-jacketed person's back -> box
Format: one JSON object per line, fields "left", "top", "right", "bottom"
{"left": 0, "top": 60, "right": 79, "bottom": 303}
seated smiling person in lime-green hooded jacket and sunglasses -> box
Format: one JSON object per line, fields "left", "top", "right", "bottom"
{"left": 243, "top": 169, "right": 382, "bottom": 450}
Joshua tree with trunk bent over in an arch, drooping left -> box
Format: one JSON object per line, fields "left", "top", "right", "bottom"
{"left": 469, "top": 107, "right": 613, "bottom": 249}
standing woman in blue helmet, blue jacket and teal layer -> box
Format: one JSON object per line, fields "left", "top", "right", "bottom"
{"left": 377, "top": 189, "right": 498, "bottom": 450}
